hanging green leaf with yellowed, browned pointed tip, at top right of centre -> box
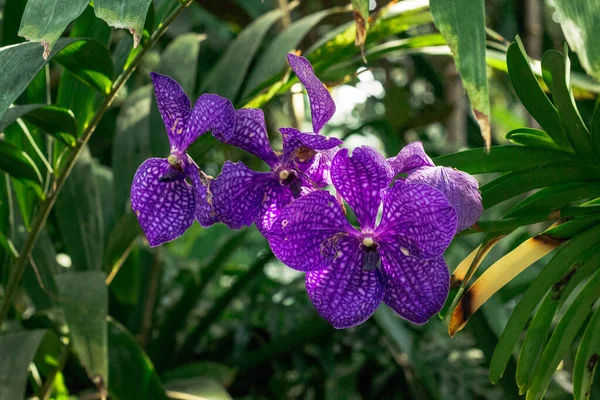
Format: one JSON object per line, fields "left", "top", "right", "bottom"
{"left": 430, "top": 0, "right": 492, "bottom": 148}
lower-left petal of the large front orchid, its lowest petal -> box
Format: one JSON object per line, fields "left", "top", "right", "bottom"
{"left": 306, "top": 238, "right": 384, "bottom": 329}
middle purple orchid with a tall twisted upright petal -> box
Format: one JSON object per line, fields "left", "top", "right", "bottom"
{"left": 209, "top": 54, "right": 342, "bottom": 235}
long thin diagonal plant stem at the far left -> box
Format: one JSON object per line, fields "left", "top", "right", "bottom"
{"left": 0, "top": 0, "right": 193, "bottom": 326}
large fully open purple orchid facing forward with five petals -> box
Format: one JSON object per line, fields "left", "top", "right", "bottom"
{"left": 268, "top": 146, "right": 457, "bottom": 329}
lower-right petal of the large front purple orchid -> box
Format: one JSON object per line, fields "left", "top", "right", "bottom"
{"left": 380, "top": 244, "right": 450, "bottom": 324}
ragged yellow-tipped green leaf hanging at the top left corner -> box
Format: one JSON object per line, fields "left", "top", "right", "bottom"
{"left": 19, "top": 0, "right": 90, "bottom": 59}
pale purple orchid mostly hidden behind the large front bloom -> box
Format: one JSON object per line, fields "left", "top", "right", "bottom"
{"left": 388, "top": 142, "right": 483, "bottom": 232}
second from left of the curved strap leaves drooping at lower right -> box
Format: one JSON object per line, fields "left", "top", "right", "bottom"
{"left": 516, "top": 249, "right": 600, "bottom": 393}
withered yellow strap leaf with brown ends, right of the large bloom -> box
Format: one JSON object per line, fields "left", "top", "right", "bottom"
{"left": 448, "top": 236, "right": 562, "bottom": 336}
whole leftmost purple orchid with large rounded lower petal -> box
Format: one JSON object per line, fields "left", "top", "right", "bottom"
{"left": 131, "top": 72, "right": 235, "bottom": 247}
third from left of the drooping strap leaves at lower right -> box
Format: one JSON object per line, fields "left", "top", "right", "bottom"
{"left": 527, "top": 264, "right": 600, "bottom": 400}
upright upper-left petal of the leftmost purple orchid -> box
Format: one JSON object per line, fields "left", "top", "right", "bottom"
{"left": 150, "top": 72, "right": 190, "bottom": 145}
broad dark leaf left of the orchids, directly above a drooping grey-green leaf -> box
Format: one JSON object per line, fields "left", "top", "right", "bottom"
{"left": 54, "top": 160, "right": 104, "bottom": 271}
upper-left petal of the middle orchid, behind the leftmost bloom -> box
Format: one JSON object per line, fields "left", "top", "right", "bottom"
{"left": 217, "top": 108, "right": 279, "bottom": 166}
